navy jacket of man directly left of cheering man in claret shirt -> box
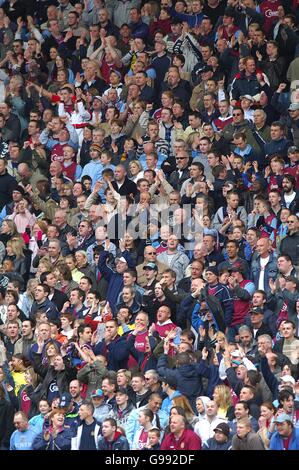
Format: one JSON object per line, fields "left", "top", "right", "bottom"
{"left": 94, "top": 336, "right": 129, "bottom": 371}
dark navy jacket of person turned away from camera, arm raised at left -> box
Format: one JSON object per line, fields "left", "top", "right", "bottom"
{"left": 157, "top": 354, "right": 202, "bottom": 411}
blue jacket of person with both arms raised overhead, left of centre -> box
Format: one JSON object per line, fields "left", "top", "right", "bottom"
{"left": 98, "top": 251, "right": 135, "bottom": 315}
